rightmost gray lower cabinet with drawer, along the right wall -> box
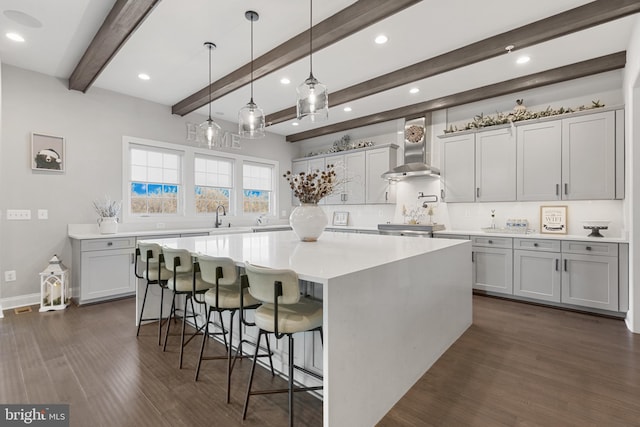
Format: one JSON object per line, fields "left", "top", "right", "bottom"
{"left": 561, "top": 242, "right": 619, "bottom": 311}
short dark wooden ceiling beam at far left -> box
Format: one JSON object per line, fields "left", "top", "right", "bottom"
{"left": 69, "top": 0, "right": 160, "bottom": 92}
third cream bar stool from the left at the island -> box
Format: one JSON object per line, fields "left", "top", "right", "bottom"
{"left": 194, "top": 255, "right": 273, "bottom": 403}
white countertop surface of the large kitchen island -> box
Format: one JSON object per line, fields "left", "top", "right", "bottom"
{"left": 139, "top": 231, "right": 463, "bottom": 283}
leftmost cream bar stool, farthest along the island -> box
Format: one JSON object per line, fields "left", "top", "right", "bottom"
{"left": 134, "top": 243, "right": 171, "bottom": 345}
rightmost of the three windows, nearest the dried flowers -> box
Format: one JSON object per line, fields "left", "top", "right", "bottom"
{"left": 242, "top": 162, "right": 273, "bottom": 214}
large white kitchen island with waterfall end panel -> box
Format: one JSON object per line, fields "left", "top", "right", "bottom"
{"left": 140, "top": 231, "right": 472, "bottom": 426}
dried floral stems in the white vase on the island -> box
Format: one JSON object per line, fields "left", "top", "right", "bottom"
{"left": 282, "top": 164, "right": 341, "bottom": 203}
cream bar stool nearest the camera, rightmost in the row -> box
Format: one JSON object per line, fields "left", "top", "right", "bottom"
{"left": 242, "top": 262, "right": 322, "bottom": 426}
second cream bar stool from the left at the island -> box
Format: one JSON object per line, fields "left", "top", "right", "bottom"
{"left": 162, "top": 247, "right": 214, "bottom": 369}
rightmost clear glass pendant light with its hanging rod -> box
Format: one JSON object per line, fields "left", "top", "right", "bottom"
{"left": 296, "top": 0, "right": 329, "bottom": 122}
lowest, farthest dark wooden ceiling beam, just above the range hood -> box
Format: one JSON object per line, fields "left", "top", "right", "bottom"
{"left": 286, "top": 51, "right": 626, "bottom": 142}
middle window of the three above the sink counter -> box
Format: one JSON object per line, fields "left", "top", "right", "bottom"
{"left": 194, "top": 157, "right": 233, "bottom": 214}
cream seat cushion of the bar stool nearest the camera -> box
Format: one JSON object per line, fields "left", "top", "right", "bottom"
{"left": 254, "top": 298, "right": 322, "bottom": 334}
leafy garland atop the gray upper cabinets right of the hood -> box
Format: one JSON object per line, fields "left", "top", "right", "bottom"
{"left": 444, "top": 99, "right": 604, "bottom": 134}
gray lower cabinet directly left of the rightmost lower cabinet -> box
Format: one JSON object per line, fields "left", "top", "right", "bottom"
{"left": 513, "top": 239, "right": 561, "bottom": 302}
